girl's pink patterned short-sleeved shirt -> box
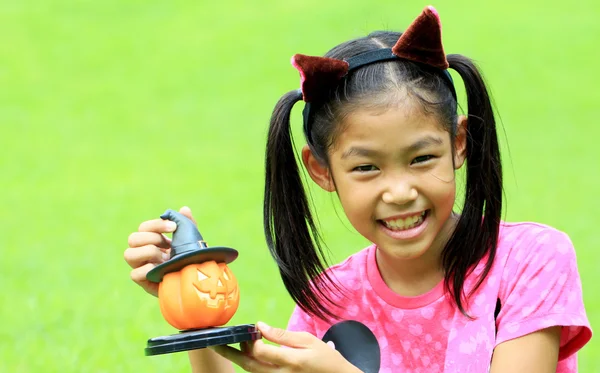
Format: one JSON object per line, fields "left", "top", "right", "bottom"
{"left": 288, "top": 223, "right": 592, "bottom": 373}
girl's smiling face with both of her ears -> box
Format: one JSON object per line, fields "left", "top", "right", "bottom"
{"left": 303, "top": 99, "right": 466, "bottom": 262}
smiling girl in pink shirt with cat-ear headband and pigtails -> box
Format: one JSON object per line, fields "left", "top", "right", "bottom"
{"left": 125, "top": 7, "right": 591, "bottom": 373}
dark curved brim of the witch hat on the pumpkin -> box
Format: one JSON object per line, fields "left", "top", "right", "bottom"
{"left": 146, "top": 247, "right": 238, "bottom": 282}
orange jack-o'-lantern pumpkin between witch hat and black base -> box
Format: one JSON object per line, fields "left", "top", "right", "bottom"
{"left": 158, "top": 261, "right": 240, "bottom": 330}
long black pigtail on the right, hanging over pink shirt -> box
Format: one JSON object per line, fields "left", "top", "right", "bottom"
{"left": 442, "top": 54, "right": 502, "bottom": 316}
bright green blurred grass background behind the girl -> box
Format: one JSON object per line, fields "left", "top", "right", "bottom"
{"left": 0, "top": 0, "right": 600, "bottom": 372}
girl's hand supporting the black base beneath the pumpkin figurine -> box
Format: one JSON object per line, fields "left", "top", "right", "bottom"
{"left": 210, "top": 322, "right": 360, "bottom": 373}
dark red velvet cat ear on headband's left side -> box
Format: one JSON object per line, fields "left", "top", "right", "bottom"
{"left": 292, "top": 54, "right": 348, "bottom": 102}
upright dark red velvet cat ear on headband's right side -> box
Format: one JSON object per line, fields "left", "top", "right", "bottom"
{"left": 392, "top": 6, "right": 449, "bottom": 70}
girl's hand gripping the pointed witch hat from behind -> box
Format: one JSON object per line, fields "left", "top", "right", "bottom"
{"left": 124, "top": 207, "right": 196, "bottom": 296}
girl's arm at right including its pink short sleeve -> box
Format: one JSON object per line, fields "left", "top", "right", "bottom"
{"left": 492, "top": 225, "right": 591, "bottom": 373}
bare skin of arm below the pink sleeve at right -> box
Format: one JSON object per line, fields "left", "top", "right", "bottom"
{"left": 490, "top": 326, "right": 561, "bottom": 373}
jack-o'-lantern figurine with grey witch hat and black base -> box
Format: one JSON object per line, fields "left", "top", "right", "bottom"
{"left": 145, "top": 210, "right": 261, "bottom": 355}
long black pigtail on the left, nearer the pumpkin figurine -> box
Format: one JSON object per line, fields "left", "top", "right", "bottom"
{"left": 263, "top": 90, "right": 335, "bottom": 319}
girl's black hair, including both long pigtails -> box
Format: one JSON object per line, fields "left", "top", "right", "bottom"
{"left": 264, "top": 31, "right": 502, "bottom": 318}
